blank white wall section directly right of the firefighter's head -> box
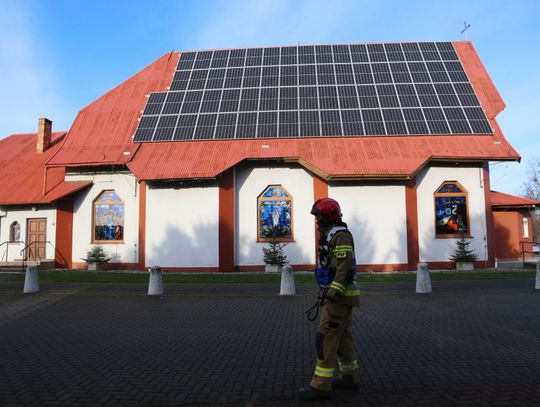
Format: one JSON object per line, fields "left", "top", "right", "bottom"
{"left": 328, "top": 183, "right": 407, "bottom": 264}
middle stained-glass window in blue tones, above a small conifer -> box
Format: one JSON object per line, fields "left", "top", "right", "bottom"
{"left": 257, "top": 185, "right": 293, "bottom": 242}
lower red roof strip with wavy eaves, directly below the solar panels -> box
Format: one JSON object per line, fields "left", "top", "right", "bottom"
{"left": 128, "top": 135, "right": 518, "bottom": 180}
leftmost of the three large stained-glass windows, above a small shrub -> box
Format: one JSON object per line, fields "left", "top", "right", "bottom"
{"left": 92, "top": 190, "right": 124, "bottom": 243}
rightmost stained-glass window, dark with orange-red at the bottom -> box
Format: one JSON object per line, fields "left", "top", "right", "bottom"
{"left": 433, "top": 181, "right": 470, "bottom": 237}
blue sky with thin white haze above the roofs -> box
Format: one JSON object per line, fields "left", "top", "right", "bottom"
{"left": 0, "top": 0, "right": 540, "bottom": 194}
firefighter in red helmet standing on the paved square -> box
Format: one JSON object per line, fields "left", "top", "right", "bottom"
{"left": 298, "top": 198, "right": 360, "bottom": 400}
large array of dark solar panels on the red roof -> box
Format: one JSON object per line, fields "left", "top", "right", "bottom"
{"left": 133, "top": 42, "right": 492, "bottom": 142}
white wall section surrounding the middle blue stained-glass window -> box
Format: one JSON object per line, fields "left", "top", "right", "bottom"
{"left": 235, "top": 166, "right": 315, "bottom": 265}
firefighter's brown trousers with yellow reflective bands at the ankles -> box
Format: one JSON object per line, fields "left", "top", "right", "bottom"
{"left": 310, "top": 303, "right": 359, "bottom": 391}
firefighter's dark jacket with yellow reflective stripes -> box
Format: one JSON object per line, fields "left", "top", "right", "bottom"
{"left": 319, "top": 226, "right": 360, "bottom": 307}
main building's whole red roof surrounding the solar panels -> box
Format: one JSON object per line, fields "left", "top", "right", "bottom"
{"left": 48, "top": 41, "right": 520, "bottom": 180}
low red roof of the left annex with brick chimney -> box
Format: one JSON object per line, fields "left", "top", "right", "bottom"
{"left": 0, "top": 133, "right": 91, "bottom": 205}
